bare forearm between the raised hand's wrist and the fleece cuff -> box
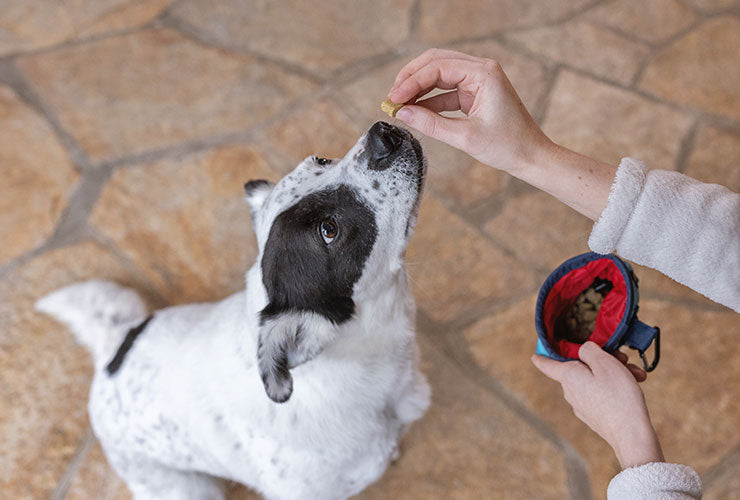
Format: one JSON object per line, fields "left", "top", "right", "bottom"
{"left": 509, "top": 141, "right": 617, "bottom": 221}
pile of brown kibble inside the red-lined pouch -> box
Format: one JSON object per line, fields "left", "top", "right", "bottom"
{"left": 555, "top": 278, "right": 613, "bottom": 344}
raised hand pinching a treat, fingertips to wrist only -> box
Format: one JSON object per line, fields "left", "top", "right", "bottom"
{"left": 388, "top": 49, "right": 554, "bottom": 175}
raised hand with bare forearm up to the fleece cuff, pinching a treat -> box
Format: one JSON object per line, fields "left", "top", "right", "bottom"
{"left": 388, "top": 49, "right": 616, "bottom": 220}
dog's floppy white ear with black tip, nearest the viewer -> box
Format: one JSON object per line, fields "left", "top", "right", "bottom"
{"left": 257, "top": 306, "right": 336, "bottom": 403}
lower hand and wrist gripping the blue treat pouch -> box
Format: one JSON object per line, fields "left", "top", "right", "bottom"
{"left": 532, "top": 342, "right": 665, "bottom": 469}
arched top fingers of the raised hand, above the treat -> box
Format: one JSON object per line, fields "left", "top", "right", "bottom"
{"left": 388, "top": 59, "right": 487, "bottom": 102}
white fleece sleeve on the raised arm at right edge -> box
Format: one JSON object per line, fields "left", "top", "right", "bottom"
{"left": 588, "top": 158, "right": 740, "bottom": 312}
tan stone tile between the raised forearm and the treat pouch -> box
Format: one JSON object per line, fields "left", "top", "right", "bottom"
{"left": 485, "top": 192, "right": 593, "bottom": 272}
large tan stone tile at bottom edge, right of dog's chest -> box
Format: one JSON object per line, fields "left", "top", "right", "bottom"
{"left": 356, "top": 332, "right": 569, "bottom": 500}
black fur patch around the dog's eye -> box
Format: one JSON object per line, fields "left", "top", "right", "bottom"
{"left": 261, "top": 185, "right": 378, "bottom": 323}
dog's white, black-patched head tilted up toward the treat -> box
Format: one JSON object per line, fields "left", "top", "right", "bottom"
{"left": 244, "top": 122, "right": 426, "bottom": 403}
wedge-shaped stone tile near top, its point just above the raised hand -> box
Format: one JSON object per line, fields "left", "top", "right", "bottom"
{"left": 506, "top": 20, "right": 649, "bottom": 85}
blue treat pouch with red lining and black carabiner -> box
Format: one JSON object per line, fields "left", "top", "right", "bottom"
{"left": 535, "top": 252, "right": 660, "bottom": 371}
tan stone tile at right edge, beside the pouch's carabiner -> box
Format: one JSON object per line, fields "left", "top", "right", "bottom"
{"left": 640, "top": 300, "right": 740, "bottom": 474}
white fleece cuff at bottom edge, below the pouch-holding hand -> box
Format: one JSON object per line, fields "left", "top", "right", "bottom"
{"left": 606, "top": 462, "right": 702, "bottom": 500}
